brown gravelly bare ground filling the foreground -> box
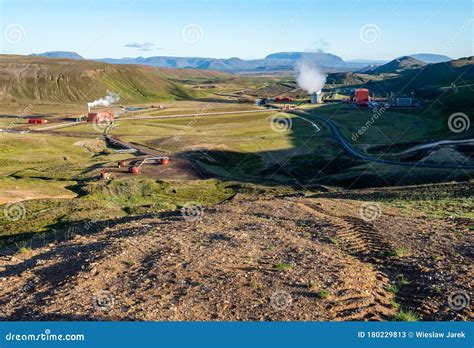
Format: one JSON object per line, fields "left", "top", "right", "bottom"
{"left": 0, "top": 194, "right": 473, "bottom": 321}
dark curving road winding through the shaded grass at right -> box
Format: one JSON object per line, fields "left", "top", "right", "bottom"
{"left": 286, "top": 109, "right": 474, "bottom": 170}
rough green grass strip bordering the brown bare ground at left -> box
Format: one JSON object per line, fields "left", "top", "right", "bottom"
{"left": 0, "top": 178, "right": 233, "bottom": 237}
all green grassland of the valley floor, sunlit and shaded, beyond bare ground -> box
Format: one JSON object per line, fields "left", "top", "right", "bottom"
{"left": 0, "top": 95, "right": 472, "bottom": 241}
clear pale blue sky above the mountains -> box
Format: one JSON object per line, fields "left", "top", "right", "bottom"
{"left": 0, "top": 0, "right": 474, "bottom": 60}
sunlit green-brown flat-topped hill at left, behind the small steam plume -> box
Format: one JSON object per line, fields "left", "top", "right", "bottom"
{"left": 0, "top": 55, "right": 212, "bottom": 103}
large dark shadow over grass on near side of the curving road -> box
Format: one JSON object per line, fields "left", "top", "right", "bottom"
{"left": 177, "top": 107, "right": 474, "bottom": 189}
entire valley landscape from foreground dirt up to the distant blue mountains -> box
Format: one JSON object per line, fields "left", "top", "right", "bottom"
{"left": 0, "top": 55, "right": 474, "bottom": 321}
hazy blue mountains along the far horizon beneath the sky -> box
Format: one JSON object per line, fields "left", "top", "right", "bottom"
{"left": 32, "top": 51, "right": 451, "bottom": 74}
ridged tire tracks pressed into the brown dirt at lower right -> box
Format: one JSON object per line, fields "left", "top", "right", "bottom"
{"left": 300, "top": 200, "right": 470, "bottom": 320}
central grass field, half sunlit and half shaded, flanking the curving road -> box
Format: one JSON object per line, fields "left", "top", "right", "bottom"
{"left": 105, "top": 105, "right": 472, "bottom": 187}
